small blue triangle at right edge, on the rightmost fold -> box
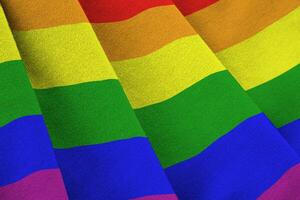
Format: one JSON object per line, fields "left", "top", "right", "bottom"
{"left": 279, "top": 119, "right": 300, "bottom": 155}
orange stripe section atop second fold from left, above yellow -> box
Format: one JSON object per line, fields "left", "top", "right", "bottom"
{"left": 1, "top": 0, "right": 88, "bottom": 30}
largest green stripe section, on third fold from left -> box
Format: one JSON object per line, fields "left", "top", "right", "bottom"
{"left": 135, "top": 71, "right": 260, "bottom": 167}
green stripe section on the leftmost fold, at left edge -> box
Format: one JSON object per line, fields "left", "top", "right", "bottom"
{"left": 0, "top": 60, "right": 41, "bottom": 126}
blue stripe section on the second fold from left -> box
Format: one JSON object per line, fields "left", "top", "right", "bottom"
{"left": 55, "top": 137, "right": 173, "bottom": 200}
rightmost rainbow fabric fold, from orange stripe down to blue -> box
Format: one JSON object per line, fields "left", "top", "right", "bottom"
{"left": 172, "top": 0, "right": 300, "bottom": 156}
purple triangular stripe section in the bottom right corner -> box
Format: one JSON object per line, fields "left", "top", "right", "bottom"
{"left": 258, "top": 164, "right": 300, "bottom": 200}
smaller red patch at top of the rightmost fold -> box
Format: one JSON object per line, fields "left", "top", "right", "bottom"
{"left": 173, "top": 0, "right": 218, "bottom": 15}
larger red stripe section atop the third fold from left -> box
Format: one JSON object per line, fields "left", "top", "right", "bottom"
{"left": 79, "top": 0, "right": 173, "bottom": 23}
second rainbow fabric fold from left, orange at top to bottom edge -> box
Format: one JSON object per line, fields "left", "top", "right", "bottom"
{"left": 3, "top": 0, "right": 177, "bottom": 200}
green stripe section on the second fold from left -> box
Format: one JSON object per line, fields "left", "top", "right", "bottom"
{"left": 36, "top": 80, "right": 144, "bottom": 148}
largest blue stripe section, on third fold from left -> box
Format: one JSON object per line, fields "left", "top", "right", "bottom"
{"left": 166, "top": 114, "right": 299, "bottom": 200}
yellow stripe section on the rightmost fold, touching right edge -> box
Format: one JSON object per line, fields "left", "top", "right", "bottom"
{"left": 217, "top": 8, "right": 300, "bottom": 90}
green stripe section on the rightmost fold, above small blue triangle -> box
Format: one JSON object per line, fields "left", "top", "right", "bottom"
{"left": 248, "top": 64, "right": 300, "bottom": 127}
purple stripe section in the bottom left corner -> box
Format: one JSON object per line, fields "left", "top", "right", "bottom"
{"left": 0, "top": 169, "right": 68, "bottom": 200}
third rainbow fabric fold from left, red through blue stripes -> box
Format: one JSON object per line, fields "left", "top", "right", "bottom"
{"left": 80, "top": 0, "right": 299, "bottom": 199}
